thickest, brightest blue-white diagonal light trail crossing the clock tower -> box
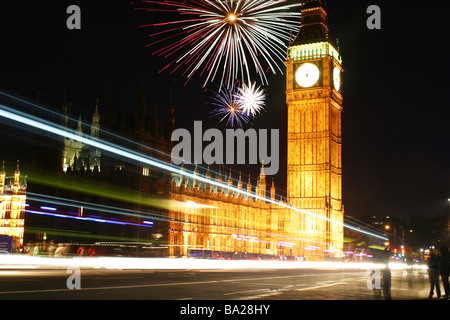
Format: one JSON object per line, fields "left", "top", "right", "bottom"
{"left": 0, "top": 104, "right": 388, "bottom": 241}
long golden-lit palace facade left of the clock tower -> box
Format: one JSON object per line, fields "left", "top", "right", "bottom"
{"left": 169, "top": 169, "right": 298, "bottom": 256}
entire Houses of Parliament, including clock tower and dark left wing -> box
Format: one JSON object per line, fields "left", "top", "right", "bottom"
{"left": 25, "top": 0, "right": 344, "bottom": 260}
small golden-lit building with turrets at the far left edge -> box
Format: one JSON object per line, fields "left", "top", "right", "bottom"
{"left": 0, "top": 163, "right": 26, "bottom": 249}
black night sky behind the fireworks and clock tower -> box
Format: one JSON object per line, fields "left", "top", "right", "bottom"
{"left": 0, "top": 0, "right": 450, "bottom": 218}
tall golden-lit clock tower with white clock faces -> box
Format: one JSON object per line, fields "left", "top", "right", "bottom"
{"left": 286, "top": 0, "right": 344, "bottom": 259}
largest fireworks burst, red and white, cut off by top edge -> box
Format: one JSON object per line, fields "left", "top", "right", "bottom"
{"left": 137, "top": 0, "right": 301, "bottom": 87}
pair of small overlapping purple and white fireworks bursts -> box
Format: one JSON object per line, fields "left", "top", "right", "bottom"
{"left": 210, "top": 83, "right": 265, "bottom": 128}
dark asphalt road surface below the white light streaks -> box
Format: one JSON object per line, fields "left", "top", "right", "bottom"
{"left": 0, "top": 269, "right": 429, "bottom": 300}
